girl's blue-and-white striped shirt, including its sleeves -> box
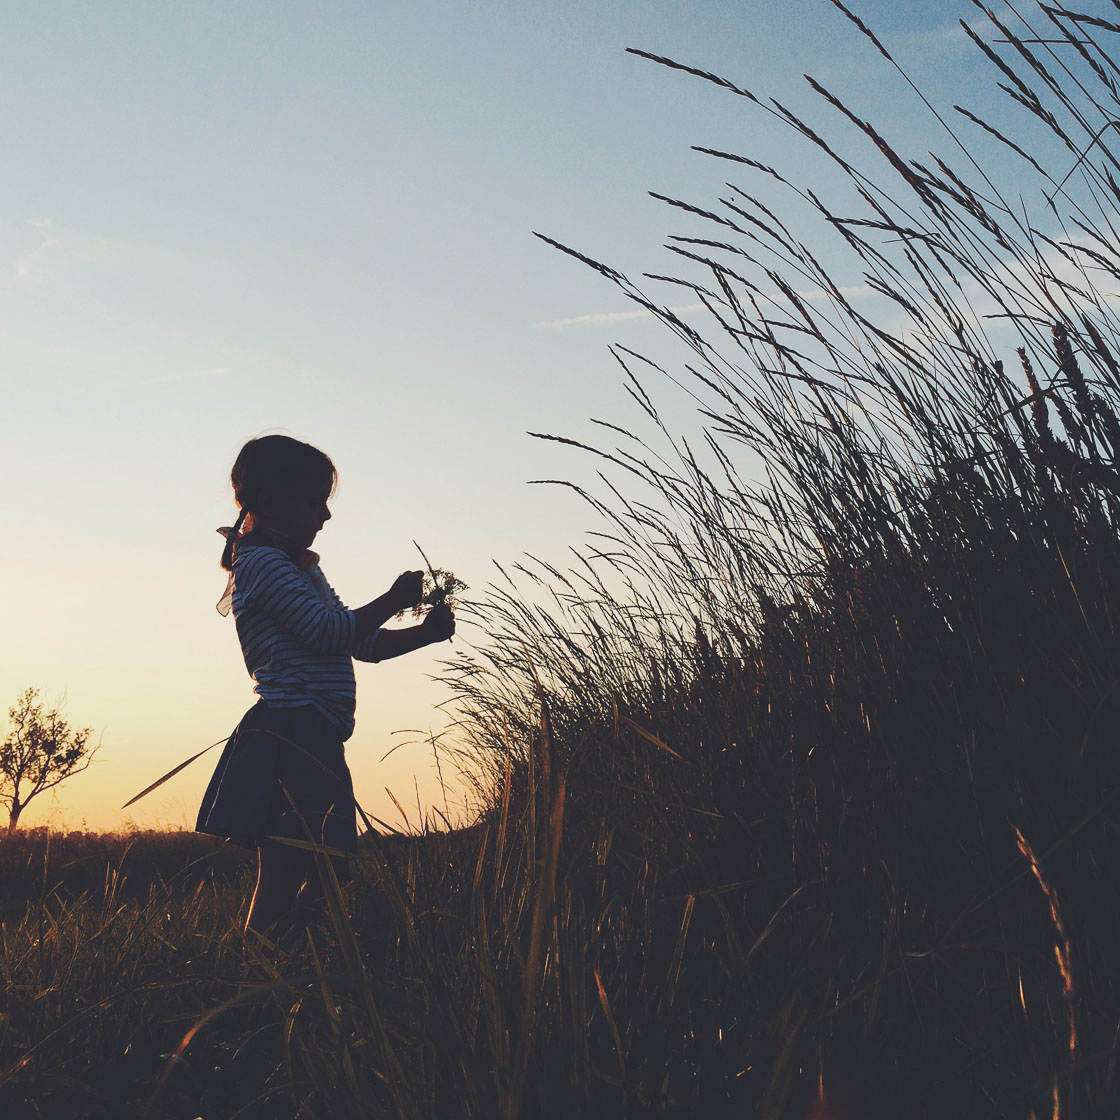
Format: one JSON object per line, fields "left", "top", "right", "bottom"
{"left": 233, "top": 545, "right": 381, "bottom": 740}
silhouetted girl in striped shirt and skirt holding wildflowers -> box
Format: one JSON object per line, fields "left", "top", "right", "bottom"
{"left": 195, "top": 436, "right": 455, "bottom": 937}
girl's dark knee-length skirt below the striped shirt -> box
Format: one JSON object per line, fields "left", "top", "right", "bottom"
{"left": 195, "top": 700, "right": 357, "bottom": 851}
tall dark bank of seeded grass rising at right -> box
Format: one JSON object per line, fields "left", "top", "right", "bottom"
{"left": 455, "top": 4, "right": 1120, "bottom": 1116}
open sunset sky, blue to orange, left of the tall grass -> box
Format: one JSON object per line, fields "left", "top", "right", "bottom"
{"left": 0, "top": 0, "right": 1039, "bottom": 829}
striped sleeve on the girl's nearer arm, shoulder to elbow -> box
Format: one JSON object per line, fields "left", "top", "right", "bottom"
{"left": 234, "top": 547, "right": 358, "bottom": 655}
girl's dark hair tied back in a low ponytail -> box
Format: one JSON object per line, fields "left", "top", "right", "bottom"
{"left": 222, "top": 436, "right": 338, "bottom": 570}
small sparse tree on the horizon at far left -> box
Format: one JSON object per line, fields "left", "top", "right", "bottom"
{"left": 0, "top": 689, "right": 100, "bottom": 832}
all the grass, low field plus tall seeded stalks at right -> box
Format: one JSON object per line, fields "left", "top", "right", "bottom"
{"left": 0, "top": 6, "right": 1120, "bottom": 1120}
